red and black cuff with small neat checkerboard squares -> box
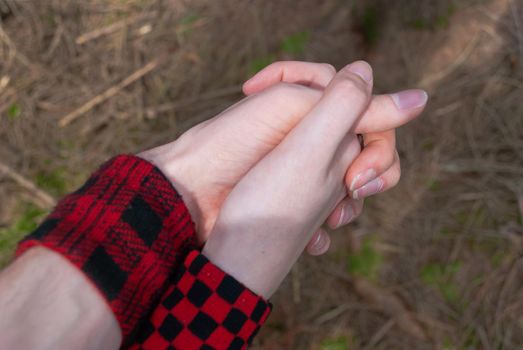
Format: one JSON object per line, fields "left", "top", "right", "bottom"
{"left": 130, "top": 250, "right": 271, "bottom": 350}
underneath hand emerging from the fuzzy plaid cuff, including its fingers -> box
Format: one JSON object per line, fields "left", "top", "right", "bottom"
{"left": 138, "top": 62, "right": 427, "bottom": 254}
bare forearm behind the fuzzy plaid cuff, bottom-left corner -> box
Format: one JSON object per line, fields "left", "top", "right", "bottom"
{"left": 0, "top": 248, "right": 122, "bottom": 349}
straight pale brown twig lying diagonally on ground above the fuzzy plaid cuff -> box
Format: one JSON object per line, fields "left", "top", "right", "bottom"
{"left": 58, "top": 58, "right": 164, "bottom": 128}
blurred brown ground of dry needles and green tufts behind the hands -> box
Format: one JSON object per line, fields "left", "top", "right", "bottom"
{"left": 0, "top": 0, "right": 523, "bottom": 350}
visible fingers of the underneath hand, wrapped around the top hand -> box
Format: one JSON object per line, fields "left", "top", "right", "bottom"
{"left": 239, "top": 61, "right": 427, "bottom": 255}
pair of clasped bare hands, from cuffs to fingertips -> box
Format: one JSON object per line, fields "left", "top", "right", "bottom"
{"left": 139, "top": 61, "right": 427, "bottom": 298}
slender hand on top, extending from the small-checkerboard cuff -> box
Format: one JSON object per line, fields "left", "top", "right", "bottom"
{"left": 203, "top": 61, "right": 400, "bottom": 298}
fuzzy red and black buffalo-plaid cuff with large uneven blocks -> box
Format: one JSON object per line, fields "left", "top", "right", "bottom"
{"left": 17, "top": 155, "right": 195, "bottom": 339}
